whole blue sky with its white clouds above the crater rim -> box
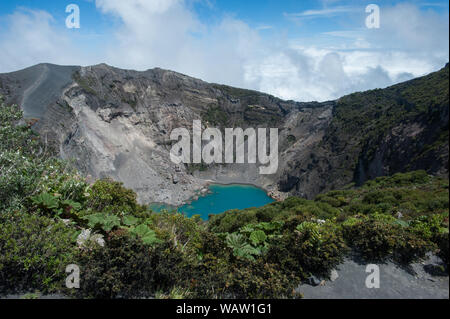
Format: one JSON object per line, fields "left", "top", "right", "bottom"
{"left": 0, "top": 0, "right": 449, "bottom": 100}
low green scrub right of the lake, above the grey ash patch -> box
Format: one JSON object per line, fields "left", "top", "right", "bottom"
{"left": 209, "top": 171, "right": 449, "bottom": 272}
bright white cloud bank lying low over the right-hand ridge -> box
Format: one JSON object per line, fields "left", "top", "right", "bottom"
{"left": 252, "top": 4, "right": 449, "bottom": 100}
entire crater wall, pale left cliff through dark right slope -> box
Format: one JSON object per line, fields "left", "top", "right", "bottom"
{"left": 0, "top": 64, "right": 448, "bottom": 205}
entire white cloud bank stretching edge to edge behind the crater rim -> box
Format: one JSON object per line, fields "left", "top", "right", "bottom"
{"left": 0, "top": 0, "right": 449, "bottom": 101}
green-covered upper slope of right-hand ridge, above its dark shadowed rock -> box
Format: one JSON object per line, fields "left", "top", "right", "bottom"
{"left": 333, "top": 66, "right": 449, "bottom": 146}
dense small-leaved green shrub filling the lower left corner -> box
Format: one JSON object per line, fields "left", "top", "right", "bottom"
{"left": 0, "top": 212, "right": 75, "bottom": 292}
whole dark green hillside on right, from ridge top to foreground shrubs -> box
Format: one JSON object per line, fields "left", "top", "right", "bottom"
{"left": 280, "top": 63, "right": 449, "bottom": 198}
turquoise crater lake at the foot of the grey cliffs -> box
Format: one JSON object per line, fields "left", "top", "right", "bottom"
{"left": 150, "top": 184, "right": 274, "bottom": 220}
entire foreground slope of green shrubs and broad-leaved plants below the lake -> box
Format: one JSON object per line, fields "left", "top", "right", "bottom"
{"left": 0, "top": 95, "right": 449, "bottom": 298}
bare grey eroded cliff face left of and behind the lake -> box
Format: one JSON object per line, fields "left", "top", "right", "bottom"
{"left": 1, "top": 64, "right": 331, "bottom": 205}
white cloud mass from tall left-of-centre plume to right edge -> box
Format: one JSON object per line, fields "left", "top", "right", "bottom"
{"left": 91, "top": 0, "right": 448, "bottom": 101}
